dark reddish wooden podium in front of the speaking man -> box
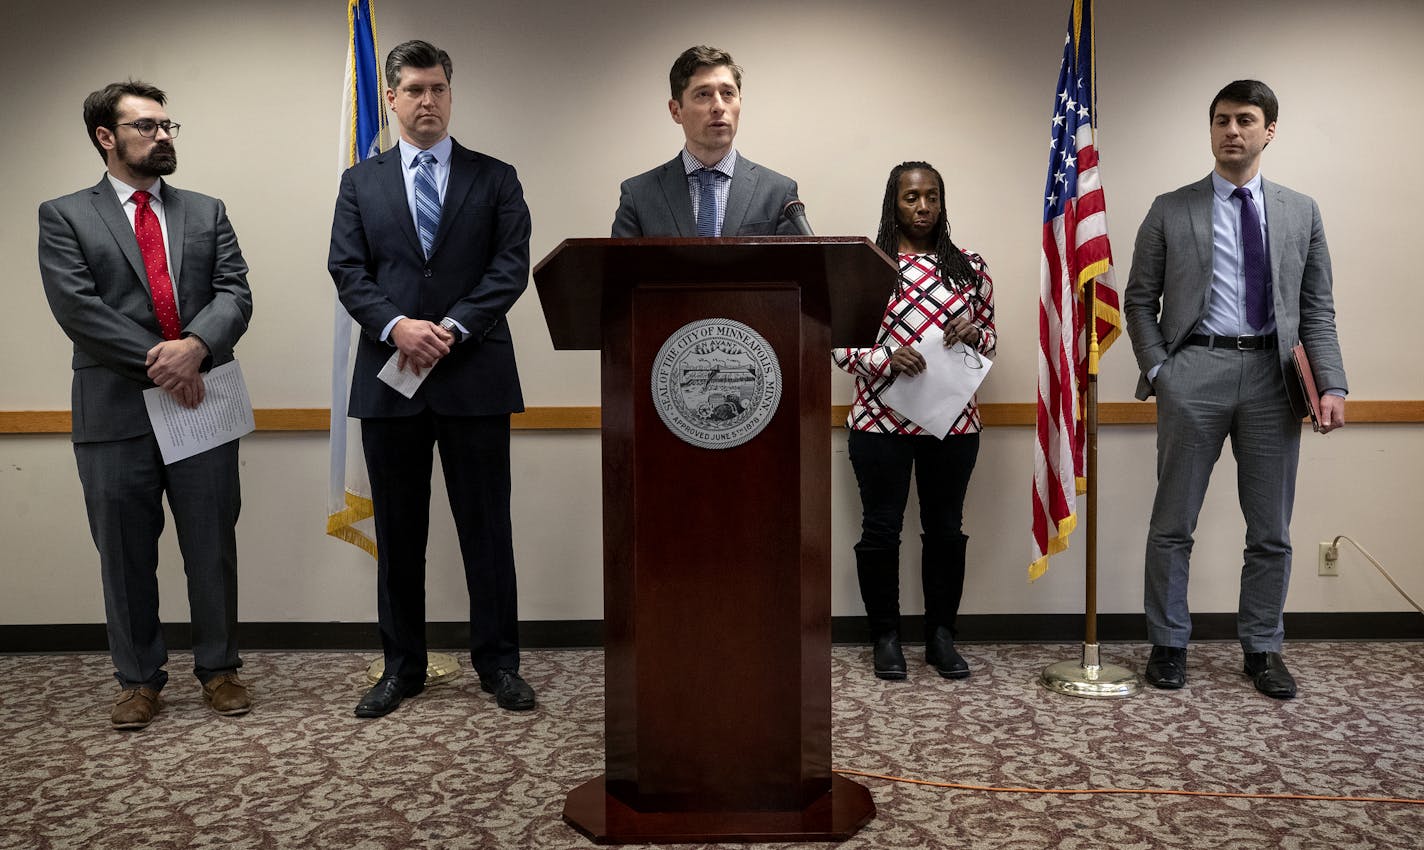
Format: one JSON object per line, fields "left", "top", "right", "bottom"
{"left": 534, "top": 236, "right": 896, "bottom": 843}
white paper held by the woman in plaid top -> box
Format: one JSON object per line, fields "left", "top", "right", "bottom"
{"left": 880, "top": 327, "right": 994, "bottom": 440}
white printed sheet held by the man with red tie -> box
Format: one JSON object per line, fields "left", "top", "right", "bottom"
{"left": 144, "top": 360, "right": 256, "bottom": 464}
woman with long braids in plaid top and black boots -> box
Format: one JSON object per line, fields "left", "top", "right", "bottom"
{"left": 832, "top": 162, "right": 998, "bottom": 679}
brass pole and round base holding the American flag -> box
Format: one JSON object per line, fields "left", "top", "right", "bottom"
{"left": 1040, "top": 0, "right": 1142, "bottom": 699}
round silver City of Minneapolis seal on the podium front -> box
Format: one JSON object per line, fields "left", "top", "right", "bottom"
{"left": 652, "top": 319, "right": 782, "bottom": 448}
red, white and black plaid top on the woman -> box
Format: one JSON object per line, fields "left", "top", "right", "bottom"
{"left": 830, "top": 251, "right": 998, "bottom": 434}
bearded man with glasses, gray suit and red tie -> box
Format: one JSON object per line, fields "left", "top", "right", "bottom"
{"left": 40, "top": 80, "right": 252, "bottom": 729}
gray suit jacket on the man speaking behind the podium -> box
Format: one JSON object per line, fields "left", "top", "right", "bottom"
{"left": 612, "top": 154, "right": 796, "bottom": 238}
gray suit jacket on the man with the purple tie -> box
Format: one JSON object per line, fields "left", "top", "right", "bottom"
{"left": 1122, "top": 175, "right": 1349, "bottom": 416}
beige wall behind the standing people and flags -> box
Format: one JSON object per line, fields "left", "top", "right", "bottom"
{"left": 0, "top": 0, "right": 1424, "bottom": 624}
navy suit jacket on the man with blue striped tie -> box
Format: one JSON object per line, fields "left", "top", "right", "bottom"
{"left": 328, "top": 142, "right": 530, "bottom": 419}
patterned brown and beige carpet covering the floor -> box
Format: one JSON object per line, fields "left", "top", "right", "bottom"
{"left": 0, "top": 644, "right": 1424, "bottom": 850}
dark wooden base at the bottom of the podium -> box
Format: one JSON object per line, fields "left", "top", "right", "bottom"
{"left": 564, "top": 775, "right": 876, "bottom": 844}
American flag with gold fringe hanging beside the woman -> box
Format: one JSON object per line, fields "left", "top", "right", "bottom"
{"left": 1028, "top": 0, "right": 1122, "bottom": 581}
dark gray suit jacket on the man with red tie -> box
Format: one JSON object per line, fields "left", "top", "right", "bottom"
{"left": 40, "top": 177, "right": 252, "bottom": 443}
